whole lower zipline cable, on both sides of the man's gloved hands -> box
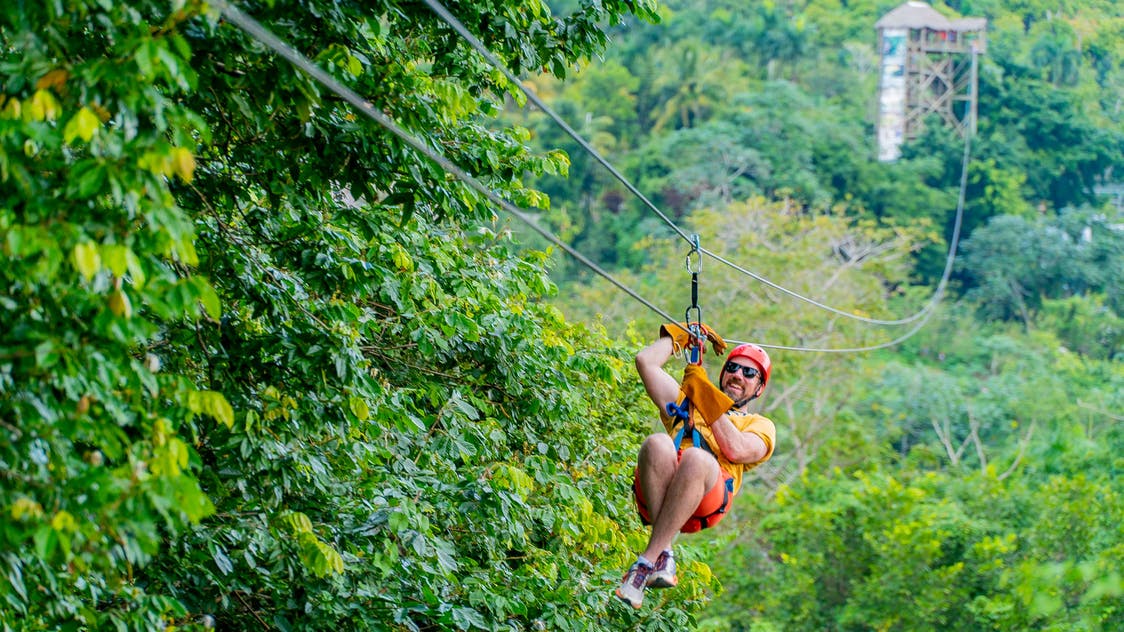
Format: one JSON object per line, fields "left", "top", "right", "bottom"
{"left": 214, "top": 0, "right": 970, "bottom": 353}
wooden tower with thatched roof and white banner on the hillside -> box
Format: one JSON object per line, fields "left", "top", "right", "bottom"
{"left": 874, "top": 0, "right": 987, "bottom": 162}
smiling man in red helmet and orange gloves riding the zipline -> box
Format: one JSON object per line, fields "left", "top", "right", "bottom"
{"left": 616, "top": 324, "right": 777, "bottom": 608}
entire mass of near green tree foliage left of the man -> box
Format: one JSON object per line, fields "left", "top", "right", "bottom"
{"left": 0, "top": 0, "right": 711, "bottom": 630}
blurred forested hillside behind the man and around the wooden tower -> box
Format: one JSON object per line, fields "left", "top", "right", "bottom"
{"left": 526, "top": 0, "right": 1124, "bottom": 630}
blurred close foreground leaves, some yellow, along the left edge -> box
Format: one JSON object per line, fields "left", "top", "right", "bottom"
{"left": 0, "top": 4, "right": 221, "bottom": 628}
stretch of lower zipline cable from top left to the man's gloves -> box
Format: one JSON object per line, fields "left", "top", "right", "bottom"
{"left": 212, "top": 0, "right": 676, "bottom": 323}
